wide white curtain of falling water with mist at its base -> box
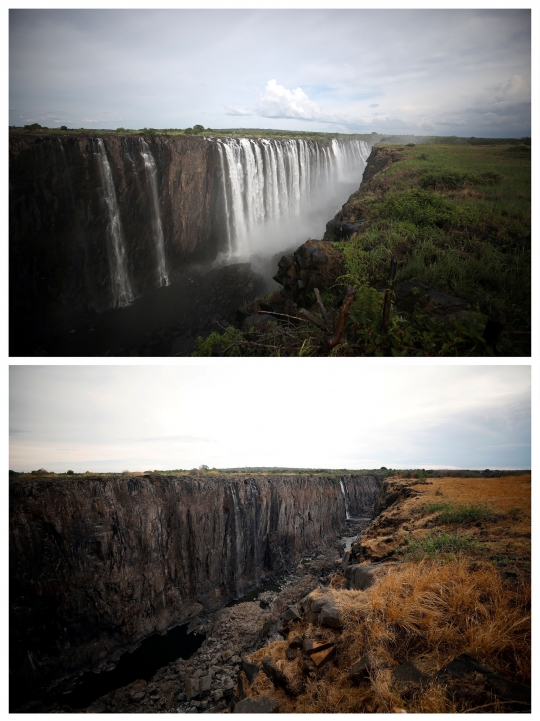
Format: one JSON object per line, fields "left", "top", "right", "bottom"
{"left": 217, "top": 138, "right": 370, "bottom": 258}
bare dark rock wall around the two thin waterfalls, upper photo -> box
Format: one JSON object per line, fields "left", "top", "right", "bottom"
{"left": 9, "top": 133, "right": 226, "bottom": 334}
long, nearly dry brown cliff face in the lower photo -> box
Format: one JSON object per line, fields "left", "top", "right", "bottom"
{"left": 10, "top": 475, "right": 381, "bottom": 692}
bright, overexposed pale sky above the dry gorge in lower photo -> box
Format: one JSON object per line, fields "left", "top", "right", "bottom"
{"left": 10, "top": 366, "right": 531, "bottom": 471}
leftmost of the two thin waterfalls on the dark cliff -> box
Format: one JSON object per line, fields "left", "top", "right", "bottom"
{"left": 94, "top": 138, "right": 134, "bottom": 307}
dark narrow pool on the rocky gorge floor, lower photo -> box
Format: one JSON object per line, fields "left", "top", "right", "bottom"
{"left": 44, "top": 623, "right": 205, "bottom": 709}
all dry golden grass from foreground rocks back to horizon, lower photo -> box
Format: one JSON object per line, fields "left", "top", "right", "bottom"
{"left": 237, "top": 474, "right": 531, "bottom": 713}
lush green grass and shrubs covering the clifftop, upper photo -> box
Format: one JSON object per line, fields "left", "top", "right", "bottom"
{"left": 195, "top": 139, "right": 531, "bottom": 356}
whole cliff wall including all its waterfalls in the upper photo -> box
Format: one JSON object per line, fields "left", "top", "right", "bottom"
{"left": 10, "top": 133, "right": 370, "bottom": 355}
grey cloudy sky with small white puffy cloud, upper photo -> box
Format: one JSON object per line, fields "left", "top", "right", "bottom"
{"left": 10, "top": 9, "right": 531, "bottom": 137}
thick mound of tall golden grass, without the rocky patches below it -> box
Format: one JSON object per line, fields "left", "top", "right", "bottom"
{"left": 334, "top": 558, "right": 530, "bottom": 679}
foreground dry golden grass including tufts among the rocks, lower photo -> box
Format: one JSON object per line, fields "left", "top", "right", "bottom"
{"left": 247, "top": 558, "right": 530, "bottom": 713}
